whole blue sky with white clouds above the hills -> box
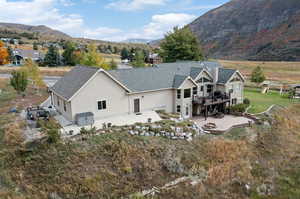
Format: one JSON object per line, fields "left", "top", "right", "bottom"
{"left": 0, "top": 0, "right": 229, "bottom": 41}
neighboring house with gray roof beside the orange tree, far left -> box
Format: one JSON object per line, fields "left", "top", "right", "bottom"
{"left": 13, "top": 49, "right": 44, "bottom": 66}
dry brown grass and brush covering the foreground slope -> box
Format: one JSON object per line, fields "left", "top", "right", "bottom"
{"left": 0, "top": 78, "right": 300, "bottom": 199}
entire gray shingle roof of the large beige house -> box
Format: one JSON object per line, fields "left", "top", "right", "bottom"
{"left": 51, "top": 61, "right": 236, "bottom": 100}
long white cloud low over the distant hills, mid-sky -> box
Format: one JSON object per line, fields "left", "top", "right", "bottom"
{"left": 84, "top": 13, "right": 196, "bottom": 41}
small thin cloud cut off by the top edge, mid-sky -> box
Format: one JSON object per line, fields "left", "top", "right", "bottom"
{"left": 106, "top": 0, "right": 167, "bottom": 11}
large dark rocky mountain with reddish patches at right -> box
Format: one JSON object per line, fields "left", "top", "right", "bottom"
{"left": 189, "top": 0, "right": 300, "bottom": 61}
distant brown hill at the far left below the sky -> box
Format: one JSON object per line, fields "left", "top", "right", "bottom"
{"left": 0, "top": 23, "right": 71, "bottom": 40}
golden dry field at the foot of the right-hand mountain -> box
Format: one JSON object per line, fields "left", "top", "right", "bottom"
{"left": 219, "top": 60, "right": 300, "bottom": 83}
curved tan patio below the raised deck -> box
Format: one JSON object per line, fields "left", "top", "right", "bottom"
{"left": 192, "top": 115, "right": 253, "bottom": 132}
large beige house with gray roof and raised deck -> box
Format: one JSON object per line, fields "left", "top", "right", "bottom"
{"left": 50, "top": 62, "right": 245, "bottom": 123}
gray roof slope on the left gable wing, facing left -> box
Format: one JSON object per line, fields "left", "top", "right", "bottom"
{"left": 51, "top": 66, "right": 99, "bottom": 100}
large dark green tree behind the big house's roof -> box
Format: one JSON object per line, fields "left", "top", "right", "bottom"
{"left": 160, "top": 27, "right": 203, "bottom": 62}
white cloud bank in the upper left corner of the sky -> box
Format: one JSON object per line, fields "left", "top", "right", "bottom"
{"left": 0, "top": 0, "right": 84, "bottom": 35}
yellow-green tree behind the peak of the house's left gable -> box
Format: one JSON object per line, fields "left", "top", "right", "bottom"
{"left": 80, "top": 44, "right": 109, "bottom": 70}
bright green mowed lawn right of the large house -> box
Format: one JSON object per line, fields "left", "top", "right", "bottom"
{"left": 245, "top": 88, "right": 300, "bottom": 113}
